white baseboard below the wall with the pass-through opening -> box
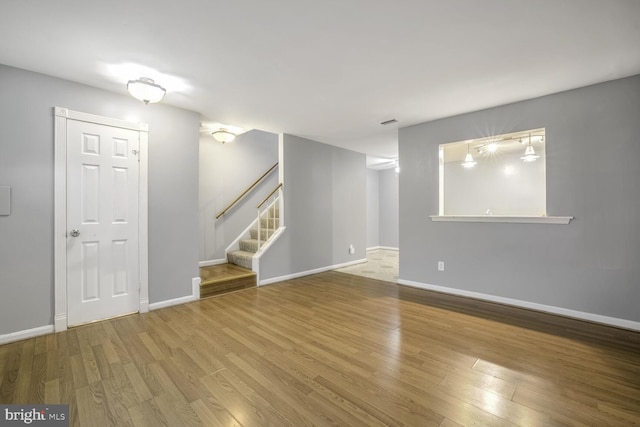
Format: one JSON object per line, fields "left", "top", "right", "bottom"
{"left": 398, "top": 279, "right": 640, "bottom": 331}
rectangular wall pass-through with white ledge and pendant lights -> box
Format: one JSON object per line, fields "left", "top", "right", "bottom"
{"left": 430, "top": 128, "right": 571, "bottom": 224}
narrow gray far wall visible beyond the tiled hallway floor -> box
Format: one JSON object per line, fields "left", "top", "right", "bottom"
{"left": 378, "top": 168, "right": 400, "bottom": 248}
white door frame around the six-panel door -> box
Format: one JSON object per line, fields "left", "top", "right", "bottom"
{"left": 53, "top": 107, "right": 149, "bottom": 332}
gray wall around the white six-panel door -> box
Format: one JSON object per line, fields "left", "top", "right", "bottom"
{"left": 0, "top": 65, "right": 199, "bottom": 334}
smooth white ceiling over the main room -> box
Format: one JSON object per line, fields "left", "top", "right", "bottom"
{"left": 0, "top": 0, "right": 640, "bottom": 158}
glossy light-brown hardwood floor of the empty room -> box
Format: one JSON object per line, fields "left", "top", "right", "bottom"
{"left": 0, "top": 272, "right": 640, "bottom": 427}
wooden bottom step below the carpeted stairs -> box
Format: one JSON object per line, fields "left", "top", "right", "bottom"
{"left": 200, "top": 264, "right": 257, "bottom": 298}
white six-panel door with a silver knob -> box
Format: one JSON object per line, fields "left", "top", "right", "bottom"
{"left": 67, "top": 120, "right": 140, "bottom": 326}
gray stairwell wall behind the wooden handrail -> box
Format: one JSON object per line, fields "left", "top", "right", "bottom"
{"left": 199, "top": 130, "right": 278, "bottom": 261}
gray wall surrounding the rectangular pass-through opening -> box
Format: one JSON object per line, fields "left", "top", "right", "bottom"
{"left": 399, "top": 76, "right": 640, "bottom": 321}
